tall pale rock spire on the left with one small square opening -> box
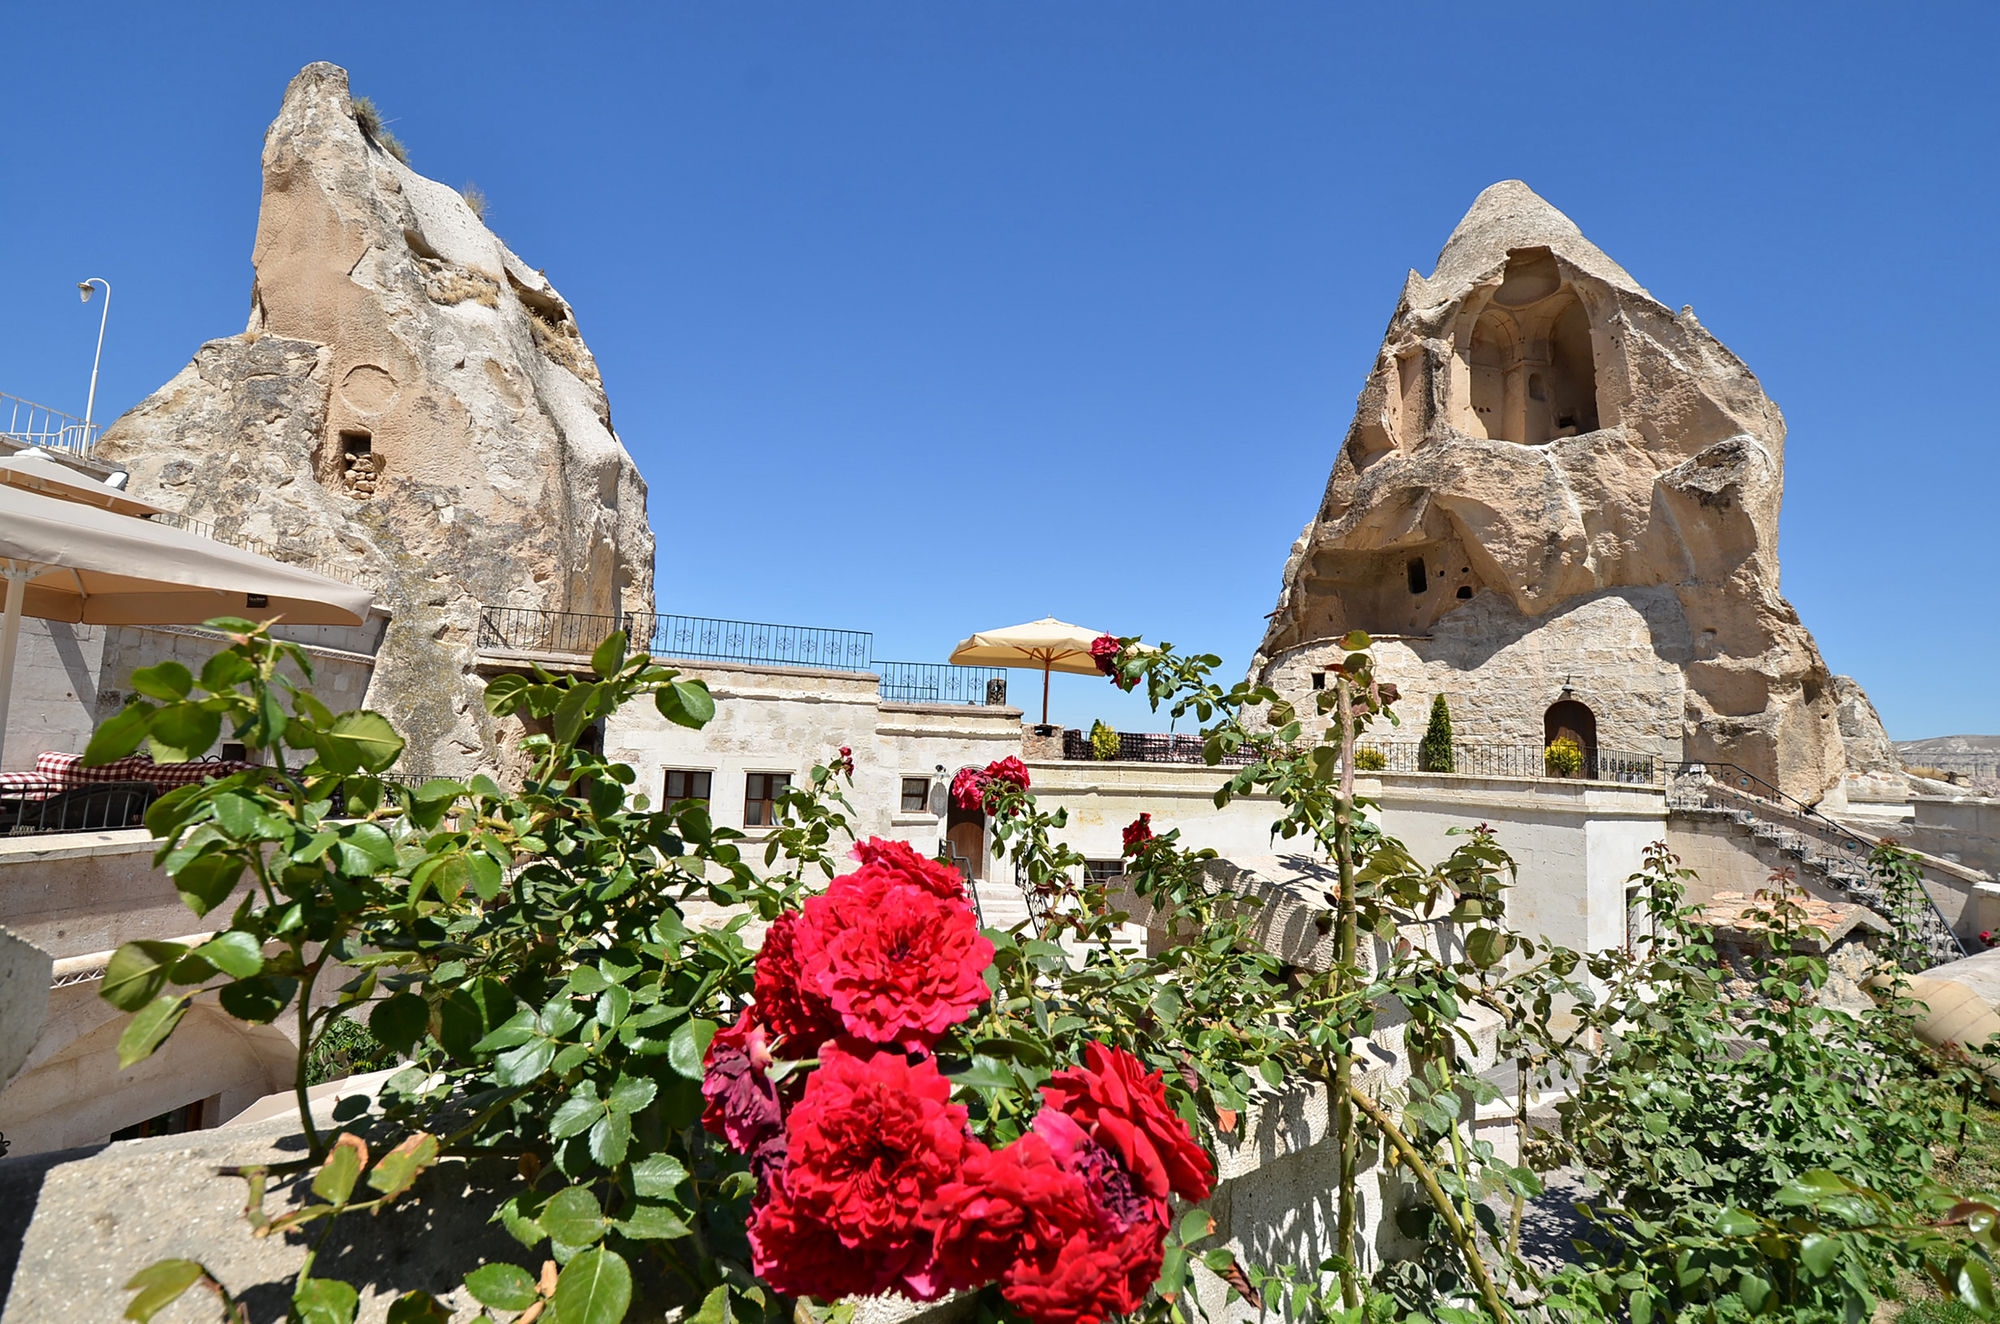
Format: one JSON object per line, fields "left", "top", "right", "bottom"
{"left": 96, "top": 64, "right": 652, "bottom": 772}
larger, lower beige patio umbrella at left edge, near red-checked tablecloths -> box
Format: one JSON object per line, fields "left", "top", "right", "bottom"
{"left": 0, "top": 484, "right": 374, "bottom": 764}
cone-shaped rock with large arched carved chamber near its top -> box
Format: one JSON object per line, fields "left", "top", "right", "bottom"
{"left": 1252, "top": 180, "right": 1894, "bottom": 800}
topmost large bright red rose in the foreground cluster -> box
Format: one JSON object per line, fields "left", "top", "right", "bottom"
{"left": 796, "top": 870, "right": 994, "bottom": 1050}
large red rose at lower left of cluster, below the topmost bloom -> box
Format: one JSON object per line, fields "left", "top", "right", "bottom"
{"left": 750, "top": 1044, "right": 980, "bottom": 1300}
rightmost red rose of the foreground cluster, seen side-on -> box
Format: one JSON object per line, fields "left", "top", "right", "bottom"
{"left": 1042, "top": 1042, "right": 1214, "bottom": 1200}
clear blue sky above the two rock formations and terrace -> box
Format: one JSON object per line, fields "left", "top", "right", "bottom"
{"left": 0, "top": 0, "right": 2000, "bottom": 738}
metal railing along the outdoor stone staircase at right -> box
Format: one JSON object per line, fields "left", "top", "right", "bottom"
{"left": 1666, "top": 762, "right": 1966, "bottom": 968}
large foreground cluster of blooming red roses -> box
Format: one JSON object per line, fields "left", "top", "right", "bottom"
{"left": 702, "top": 844, "right": 1214, "bottom": 1324}
